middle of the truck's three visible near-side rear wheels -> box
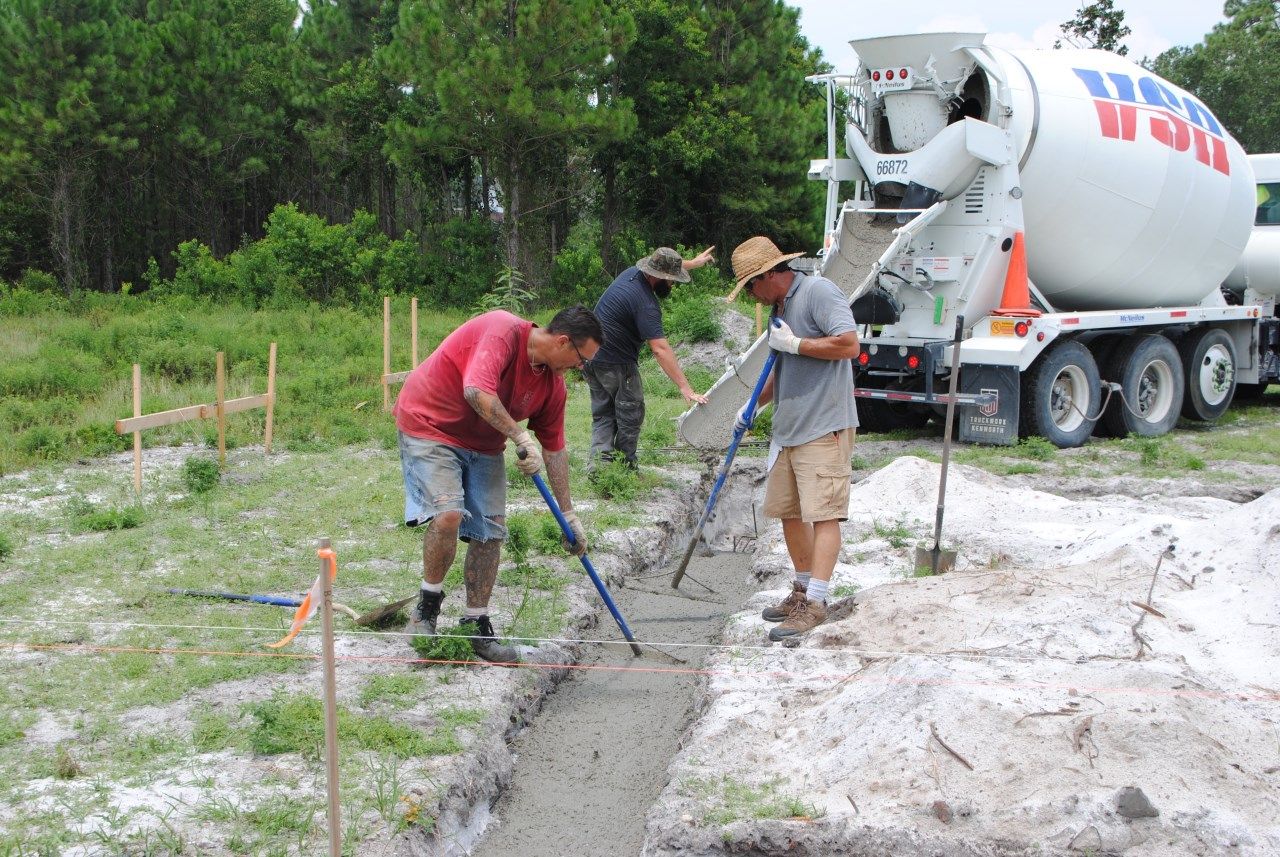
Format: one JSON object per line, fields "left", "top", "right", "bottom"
{"left": 1102, "top": 334, "right": 1187, "bottom": 437}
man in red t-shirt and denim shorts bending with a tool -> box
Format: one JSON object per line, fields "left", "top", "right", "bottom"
{"left": 396, "top": 306, "right": 604, "bottom": 664}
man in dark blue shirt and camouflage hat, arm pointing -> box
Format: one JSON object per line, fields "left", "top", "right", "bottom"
{"left": 582, "top": 247, "right": 716, "bottom": 469}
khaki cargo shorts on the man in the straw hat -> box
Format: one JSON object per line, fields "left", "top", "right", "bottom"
{"left": 764, "top": 429, "right": 854, "bottom": 523}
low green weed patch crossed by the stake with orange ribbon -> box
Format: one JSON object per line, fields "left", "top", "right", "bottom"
{"left": 246, "top": 692, "right": 439, "bottom": 759}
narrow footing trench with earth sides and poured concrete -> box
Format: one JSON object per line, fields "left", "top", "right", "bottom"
{"left": 396, "top": 462, "right": 764, "bottom": 857}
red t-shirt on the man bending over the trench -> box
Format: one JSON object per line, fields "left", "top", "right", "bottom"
{"left": 396, "top": 310, "right": 566, "bottom": 455}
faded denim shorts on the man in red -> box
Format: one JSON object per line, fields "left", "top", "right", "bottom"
{"left": 399, "top": 431, "right": 507, "bottom": 541}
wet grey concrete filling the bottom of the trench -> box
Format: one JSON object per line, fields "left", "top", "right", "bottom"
{"left": 471, "top": 553, "right": 759, "bottom": 857}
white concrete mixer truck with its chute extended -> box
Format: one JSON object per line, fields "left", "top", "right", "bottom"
{"left": 680, "top": 33, "right": 1280, "bottom": 448}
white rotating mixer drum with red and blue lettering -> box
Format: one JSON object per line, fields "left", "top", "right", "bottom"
{"left": 987, "top": 47, "right": 1254, "bottom": 310}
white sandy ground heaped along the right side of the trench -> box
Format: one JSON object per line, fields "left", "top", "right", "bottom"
{"left": 644, "top": 458, "right": 1280, "bottom": 857}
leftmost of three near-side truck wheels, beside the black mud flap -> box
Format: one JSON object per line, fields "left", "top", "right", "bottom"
{"left": 1019, "top": 339, "right": 1101, "bottom": 449}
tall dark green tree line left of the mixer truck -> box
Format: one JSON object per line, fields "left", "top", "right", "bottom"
{"left": 0, "top": 0, "right": 823, "bottom": 301}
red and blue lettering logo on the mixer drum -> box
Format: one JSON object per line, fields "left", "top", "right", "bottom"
{"left": 1071, "top": 68, "right": 1231, "bottom": 175}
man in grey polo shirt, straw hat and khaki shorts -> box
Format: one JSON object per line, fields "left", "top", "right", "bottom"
{"left": 731, "top": 235, "right": 859, "bottom": 641}
